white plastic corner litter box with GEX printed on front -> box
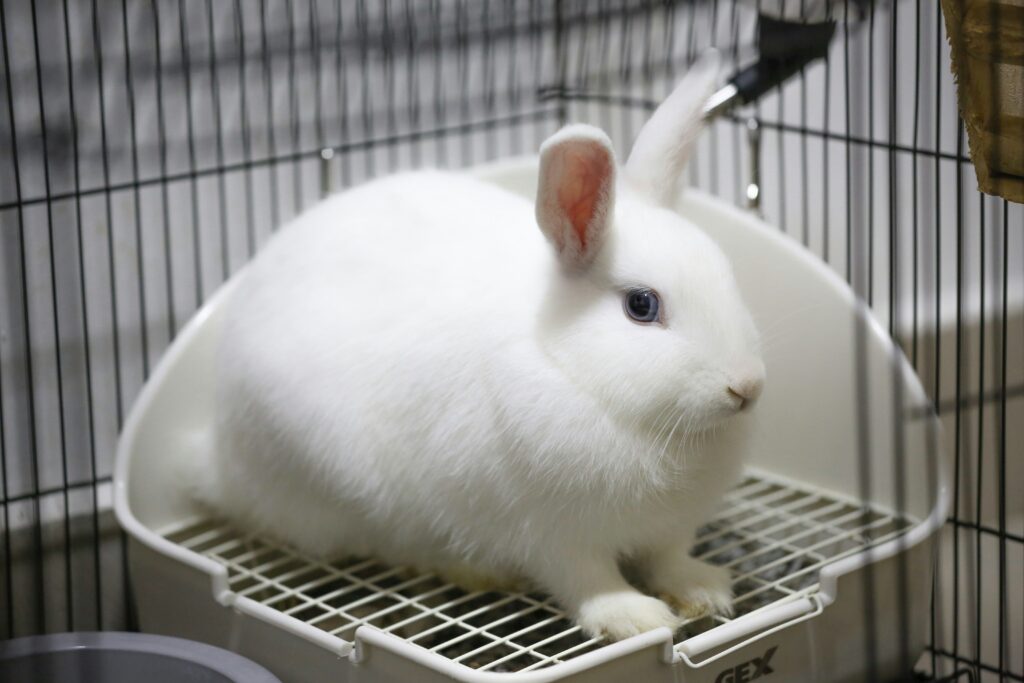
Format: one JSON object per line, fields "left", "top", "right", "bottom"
{"left": 114, "top": 159, "right": 947, "bottom": 683}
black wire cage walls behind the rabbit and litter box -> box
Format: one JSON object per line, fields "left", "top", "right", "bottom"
{"left": 0, "top": 0, "right": 1024, "bottom": 681}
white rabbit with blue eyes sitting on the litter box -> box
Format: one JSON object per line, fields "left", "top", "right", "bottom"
{"left": 197, "top": 57, "right": 764, "bottom": 639}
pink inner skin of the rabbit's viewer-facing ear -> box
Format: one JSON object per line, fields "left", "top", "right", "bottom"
{"left": 558, "top": 150, "right": 612, "bottom": 252}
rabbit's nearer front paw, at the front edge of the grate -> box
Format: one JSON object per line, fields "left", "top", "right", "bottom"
{"left": 578, "top": 591, "right": 679, "bottom": 640}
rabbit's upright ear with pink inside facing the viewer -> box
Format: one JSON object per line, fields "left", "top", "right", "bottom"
{"left": 537, "top": 125, "right": 615, "bottom": 268}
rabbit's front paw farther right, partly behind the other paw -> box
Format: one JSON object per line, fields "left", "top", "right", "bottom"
{"left": 650, "top": 557, "right": 732, "bottom": 620}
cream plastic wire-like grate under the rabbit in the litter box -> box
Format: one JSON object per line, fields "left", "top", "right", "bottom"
{"left": 165, "top": 474, "right": 914, "bottom": 672}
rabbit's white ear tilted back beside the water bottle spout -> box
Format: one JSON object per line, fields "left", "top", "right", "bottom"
{"left": 626, "top": 50, "right": 719, "bottom": 208}
